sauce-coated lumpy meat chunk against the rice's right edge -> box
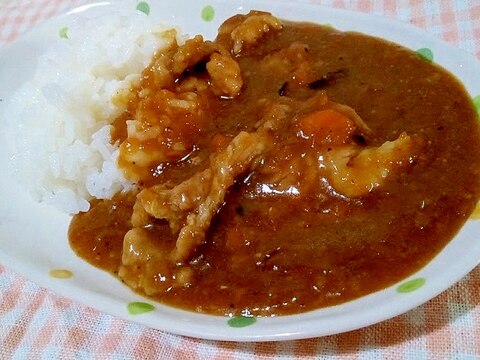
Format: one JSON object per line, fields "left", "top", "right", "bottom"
{"left": 118, "top": 89, "right": 205, "bottom": 182}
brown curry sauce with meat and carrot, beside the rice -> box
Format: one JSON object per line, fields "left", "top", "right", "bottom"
{"left": 69, "top": 11, "right": 480, "bottom": 316}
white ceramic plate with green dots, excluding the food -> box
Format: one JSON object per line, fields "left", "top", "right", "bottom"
{"left": 0, "top": 0, "right": 480, "bottom": 341}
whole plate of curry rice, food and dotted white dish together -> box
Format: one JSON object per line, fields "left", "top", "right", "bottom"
{"left": 0, "top": 0, "right": 480, "bottom": 341}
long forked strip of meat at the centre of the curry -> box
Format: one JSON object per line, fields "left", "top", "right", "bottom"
{"left": 132, "top": 128, "right": 272, "bottom": 263}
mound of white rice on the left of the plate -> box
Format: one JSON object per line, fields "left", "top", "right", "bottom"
{"left": 6, "top": 13, "right": 182, "bottom": 214}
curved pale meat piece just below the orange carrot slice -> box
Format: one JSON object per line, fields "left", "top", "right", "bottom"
{"left": 319, "top": 133, "right": 419, "bottom": 198}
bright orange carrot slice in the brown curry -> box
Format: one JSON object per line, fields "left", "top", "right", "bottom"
{"left": 299, "top": 109, "right": 355, "bottom": 145}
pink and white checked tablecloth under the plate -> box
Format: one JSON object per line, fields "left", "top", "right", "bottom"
{"left": 0, "top": 0, "right": 480, "bottom": 359}
